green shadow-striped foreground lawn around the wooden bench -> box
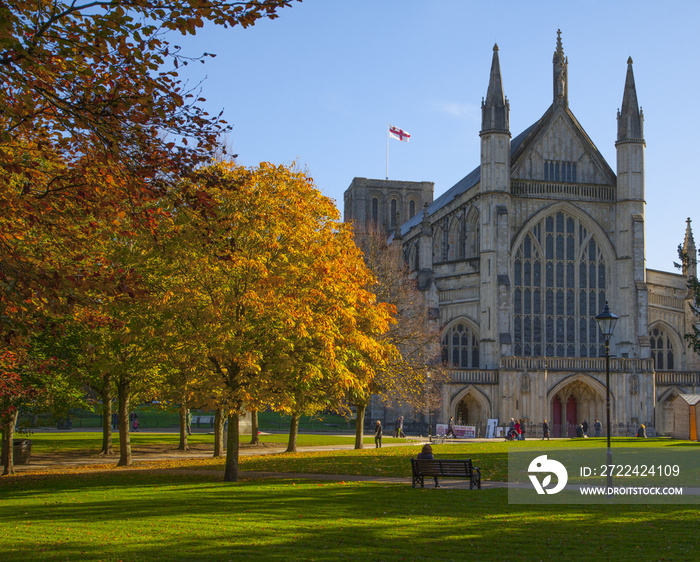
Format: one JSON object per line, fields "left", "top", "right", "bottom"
{"left": 0, "top": 434, "right": 700, "bottom": 561}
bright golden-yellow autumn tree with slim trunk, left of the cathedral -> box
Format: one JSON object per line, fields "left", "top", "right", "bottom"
{"left": 164, "top": 163, "right": 389, "bottom": 480}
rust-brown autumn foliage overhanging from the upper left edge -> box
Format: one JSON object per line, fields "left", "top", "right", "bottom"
{"left": 0, "top": 0, "right": 300, "bottom": 472}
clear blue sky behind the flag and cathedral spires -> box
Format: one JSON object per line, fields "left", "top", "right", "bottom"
{"left": 178, "top": 0, "right": 700, "bottom": 271}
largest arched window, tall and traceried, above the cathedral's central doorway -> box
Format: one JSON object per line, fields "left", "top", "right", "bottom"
{"left": 513, "top": 211, "right": 607, "bottom": 357}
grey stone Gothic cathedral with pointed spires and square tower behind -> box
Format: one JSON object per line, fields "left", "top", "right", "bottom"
{"left": 344, "top": 32, "right": 700, "bottom": 436}
